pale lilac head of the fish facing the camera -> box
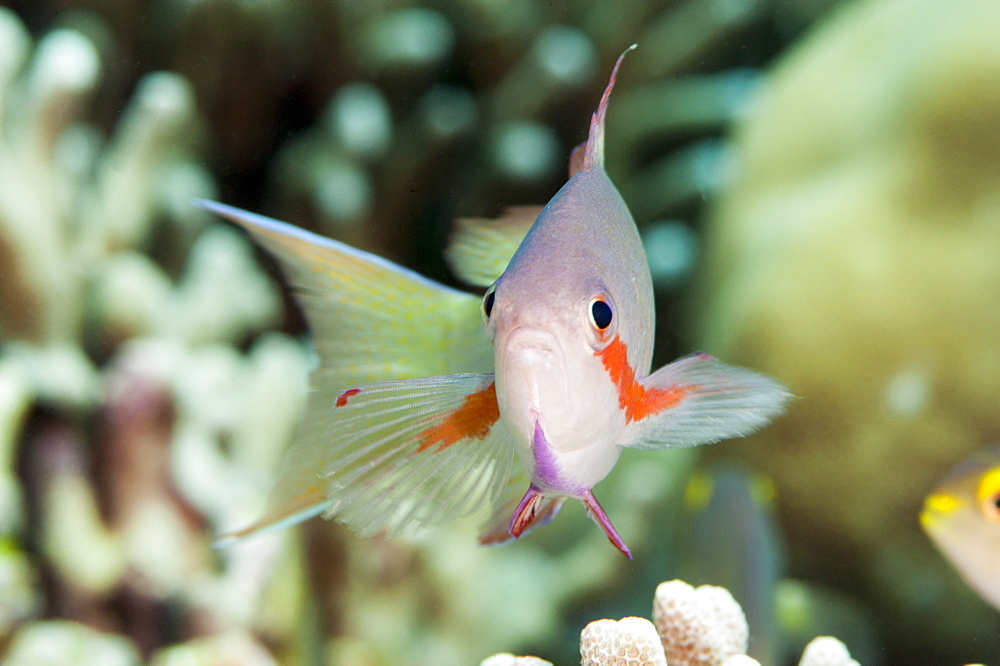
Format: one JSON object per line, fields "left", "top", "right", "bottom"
{"left": 484, "top": 168, "right": 654, "bottom": 466}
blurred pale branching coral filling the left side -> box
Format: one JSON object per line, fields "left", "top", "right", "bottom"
{"left": 0, "top": 9, "right": 308, "bottom": 663}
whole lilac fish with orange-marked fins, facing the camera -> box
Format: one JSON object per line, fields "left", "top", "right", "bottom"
{"left": 199, "top": 46, "right": 789, "bottom": 558}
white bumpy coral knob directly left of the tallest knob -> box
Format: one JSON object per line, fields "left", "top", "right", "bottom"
{"left": 580, "top": 617, "right": 667, "bottom": 666}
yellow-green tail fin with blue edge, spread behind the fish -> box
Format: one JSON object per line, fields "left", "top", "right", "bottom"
{"left": 196, "top": 201, "right": 493, "bottom": 538}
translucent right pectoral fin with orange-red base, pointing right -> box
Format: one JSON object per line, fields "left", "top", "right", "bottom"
{"left": 625, "top": 353, "right": 792, "bottom": 449}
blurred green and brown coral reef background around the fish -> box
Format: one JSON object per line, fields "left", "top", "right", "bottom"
{"left": 0, "top": 0, "right": 1000, "bottom": 666}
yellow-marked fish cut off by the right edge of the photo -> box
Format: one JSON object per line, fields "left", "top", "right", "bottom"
{"left": 920, "top": 446, "right": 1000, "bottom": 610}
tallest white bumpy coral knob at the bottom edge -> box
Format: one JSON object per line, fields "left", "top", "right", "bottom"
{"left": 653, "top": 580, "right": 749, "bottom": 666}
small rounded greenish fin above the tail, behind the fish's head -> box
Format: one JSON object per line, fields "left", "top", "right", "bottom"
{"left": 445, "top": 206, "right": 542, "bottom": 287}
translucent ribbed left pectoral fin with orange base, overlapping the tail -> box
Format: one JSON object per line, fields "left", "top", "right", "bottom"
{"left": 217, "top": 374, "right": 514, "bottom": 536}
